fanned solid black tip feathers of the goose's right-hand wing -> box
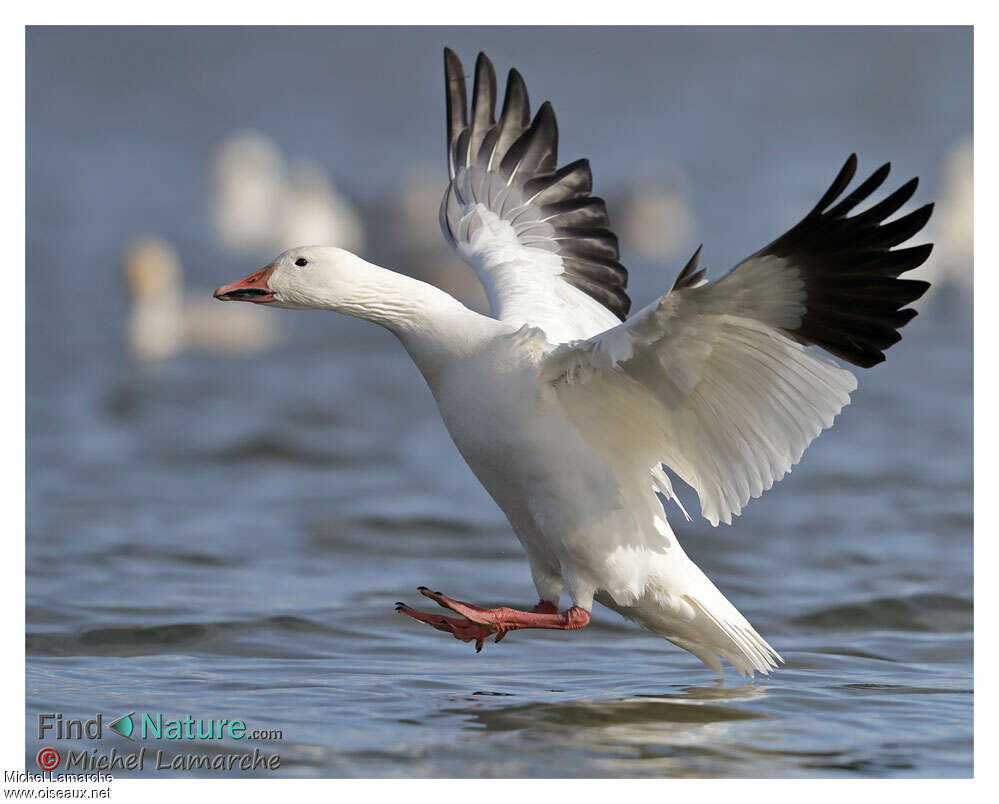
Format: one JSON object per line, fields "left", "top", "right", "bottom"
{"left": 748, "top": 154, "right": 933, "bottom": 368}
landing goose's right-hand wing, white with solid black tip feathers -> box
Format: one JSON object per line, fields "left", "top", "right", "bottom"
{"left": 546, "top": 155, "right": 933, "bottom": 525}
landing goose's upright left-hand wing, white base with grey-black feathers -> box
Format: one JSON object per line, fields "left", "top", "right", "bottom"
{"left": 440, "top": 49, "right": 631, "bottom": 343}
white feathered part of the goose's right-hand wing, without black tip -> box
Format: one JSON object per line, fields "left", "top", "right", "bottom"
{"left": 545, "top": 258, "right": 857, "bottom": 525}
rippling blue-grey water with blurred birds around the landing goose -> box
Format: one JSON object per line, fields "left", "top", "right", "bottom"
{"left": 26, "top": 27, "right": 973, "bottom": 776}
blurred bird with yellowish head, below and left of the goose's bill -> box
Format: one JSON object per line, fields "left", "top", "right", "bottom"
{"left": 123, "top": 237, "right": 277, "bottom": 363}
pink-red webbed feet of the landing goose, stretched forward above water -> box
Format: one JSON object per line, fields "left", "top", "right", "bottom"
{"left": 396, "top": 586, "right": 590, "bottom": 653}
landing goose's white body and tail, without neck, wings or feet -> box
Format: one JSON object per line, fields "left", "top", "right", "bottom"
{"left": 429, "top": 340, "right": 779, "bottom": 673}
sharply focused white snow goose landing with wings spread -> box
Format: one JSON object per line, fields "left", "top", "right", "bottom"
{"left": 215, "top": 50, "right": 931, "bottom": 676}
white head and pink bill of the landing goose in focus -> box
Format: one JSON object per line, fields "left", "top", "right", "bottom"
{"left": 215, "top": 246, "right": 378, "bottom": 316}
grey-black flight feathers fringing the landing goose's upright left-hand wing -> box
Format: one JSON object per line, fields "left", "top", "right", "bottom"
{"left": 440, "top": 48, "right": 631, "bottom": 321}
